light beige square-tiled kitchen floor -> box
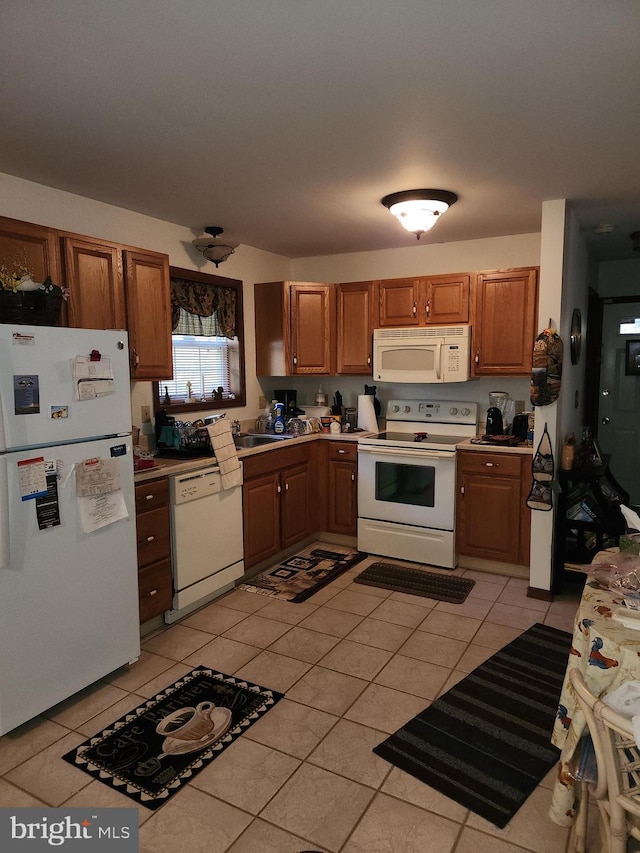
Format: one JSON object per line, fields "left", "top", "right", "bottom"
{"left": 0, "top": 543, "right": 584, "bottom": 853}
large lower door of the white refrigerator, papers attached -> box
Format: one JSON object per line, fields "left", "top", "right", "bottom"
{"left": 0, "top": 438, "right": 140, "bottom": 734}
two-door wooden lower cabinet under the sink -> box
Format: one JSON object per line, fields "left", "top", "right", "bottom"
{"left": 242, "top": 444, "right": 316, "bottom": 570}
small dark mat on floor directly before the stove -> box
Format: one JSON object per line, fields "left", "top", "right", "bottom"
{"left": 353, "top": 563, "right": 475, "bottom": 604}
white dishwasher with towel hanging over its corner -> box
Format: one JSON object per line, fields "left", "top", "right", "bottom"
{"left": 165, "top": 465, "right": 244, "bottom": 623}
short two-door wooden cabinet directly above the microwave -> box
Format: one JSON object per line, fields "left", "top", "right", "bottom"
{"left": 377, "top": 273, "right": 471, "bottom": 327}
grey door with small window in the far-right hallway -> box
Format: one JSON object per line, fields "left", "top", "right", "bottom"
{"left": 598, "top": 302, "right": 640, "bottom": 504}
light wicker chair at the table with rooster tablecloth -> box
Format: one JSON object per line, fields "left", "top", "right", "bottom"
{"left": 569, "top": 669, "right": 640, "bottom": 853}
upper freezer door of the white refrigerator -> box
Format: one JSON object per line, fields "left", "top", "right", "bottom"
{"left": 0, "top": 324, "right": 131, "bottom": 449}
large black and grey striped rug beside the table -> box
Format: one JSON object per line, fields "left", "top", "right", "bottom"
{"left": 373, "top": 623, "right": 572, "bottom": 829}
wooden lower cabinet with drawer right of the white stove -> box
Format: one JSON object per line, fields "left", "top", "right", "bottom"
{"left": 456, "top": 450, "right": 531, "bottom": 566}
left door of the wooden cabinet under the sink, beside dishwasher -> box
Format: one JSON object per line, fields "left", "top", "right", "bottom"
{"left": 242, "top": 474, "right": 280, "bottom": 569}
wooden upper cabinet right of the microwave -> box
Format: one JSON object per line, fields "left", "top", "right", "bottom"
{"left": 471, "top": 267, "right": 538, "bottom": 376}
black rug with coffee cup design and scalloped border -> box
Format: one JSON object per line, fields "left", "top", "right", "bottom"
{"left": 62, "top": 667, "right": 284, "bottom": 809}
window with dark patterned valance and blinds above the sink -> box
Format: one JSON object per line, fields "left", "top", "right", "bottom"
{"left": 154, "top": 267, "right": 246, "bottom": 413}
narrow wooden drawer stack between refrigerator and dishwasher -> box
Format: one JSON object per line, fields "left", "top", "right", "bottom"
{"left": 135, "top": 477, "right": 173, "bottom": 624}
